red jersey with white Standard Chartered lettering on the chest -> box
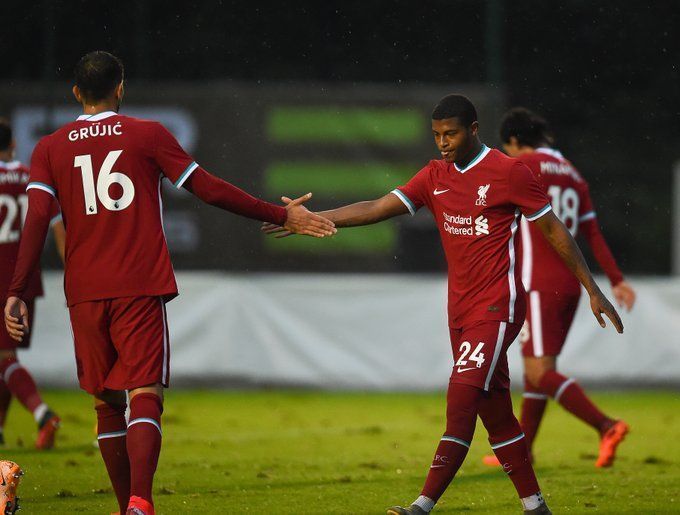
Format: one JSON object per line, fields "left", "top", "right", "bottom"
{"left": 393, "top": 146, "right": 550, "bottom": 328}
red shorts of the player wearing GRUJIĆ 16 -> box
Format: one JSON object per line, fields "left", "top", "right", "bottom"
{"left": 69, "top": 297, "right": 170, "bottom": 394}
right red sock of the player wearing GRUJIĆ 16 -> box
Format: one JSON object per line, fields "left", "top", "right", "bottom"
{"left": 127, "top": 393, "right": 163, "bottom": 504}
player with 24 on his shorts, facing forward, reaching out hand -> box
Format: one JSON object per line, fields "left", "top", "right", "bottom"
{"left": 263, "top": 95, "right": 623, "bottom": 515}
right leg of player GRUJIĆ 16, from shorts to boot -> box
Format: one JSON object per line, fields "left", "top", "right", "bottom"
{"left": 105, "top": 297, "right": 170, "bottom": 515}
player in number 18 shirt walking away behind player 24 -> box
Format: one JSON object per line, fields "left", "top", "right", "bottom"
{"left": 485, "top": 108, "right": 635, "bottom": 467}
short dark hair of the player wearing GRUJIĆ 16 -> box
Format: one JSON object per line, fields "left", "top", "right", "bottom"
{"left": 75, "top": 50, "right": 124, "bottom": 102}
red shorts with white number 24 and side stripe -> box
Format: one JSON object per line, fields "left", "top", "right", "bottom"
{"left": 449, "top": 320, "right": 522, "bottom": 391}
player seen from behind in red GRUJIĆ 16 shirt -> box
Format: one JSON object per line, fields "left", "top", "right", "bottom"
{"left": 5, "top": 51, "right": 335, "bottom": 515}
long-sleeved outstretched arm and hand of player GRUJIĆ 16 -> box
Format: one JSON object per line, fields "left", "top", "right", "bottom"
{"left": 182, "top": 168, "right": 336, "bottom": 238}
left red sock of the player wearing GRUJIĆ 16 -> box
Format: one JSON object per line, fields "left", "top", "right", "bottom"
{"left": 95, "top": 404, "right": 130, "bottom": 513}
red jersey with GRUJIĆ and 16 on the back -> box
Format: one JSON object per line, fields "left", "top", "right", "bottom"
{"left": 27, "top": 111, "right": 198, "bottom": 305}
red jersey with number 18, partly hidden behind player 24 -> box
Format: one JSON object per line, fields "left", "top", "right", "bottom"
{"left": 519, "top": 148, "right": 595, "bottom": 295}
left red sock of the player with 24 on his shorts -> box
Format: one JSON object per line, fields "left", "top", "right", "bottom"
{"left": 421, "top": 383, "right": 482, "bottom": 502}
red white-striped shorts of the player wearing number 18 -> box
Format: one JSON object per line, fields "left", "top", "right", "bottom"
{"left": 519, "top": 291, "right": 580, "bottom": 358}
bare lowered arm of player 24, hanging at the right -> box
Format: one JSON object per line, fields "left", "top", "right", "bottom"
{"left": 534, "top": 211, "right": 623, "bottom": 333}
